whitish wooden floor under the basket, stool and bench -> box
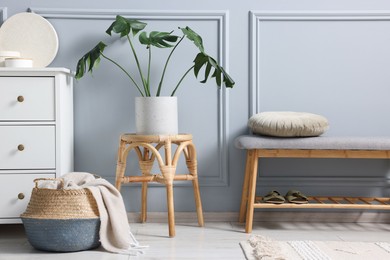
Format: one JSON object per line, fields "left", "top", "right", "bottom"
{"left": 0, "top": 218, "right": 390, "bottom": 260}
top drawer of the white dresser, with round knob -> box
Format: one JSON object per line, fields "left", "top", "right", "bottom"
{"left": 0, "top": 77, "right": 55, "bottom": 121}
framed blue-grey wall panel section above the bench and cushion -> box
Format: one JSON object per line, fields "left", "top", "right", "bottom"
{"left": 251, "top": 11, "right": 390, "bottom": 136}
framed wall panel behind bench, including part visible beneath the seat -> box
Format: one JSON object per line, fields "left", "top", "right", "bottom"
{"left": 250, "top": 11, "right": 390, "bottom": 196}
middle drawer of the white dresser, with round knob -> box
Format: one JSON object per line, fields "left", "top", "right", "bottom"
{"left": 0, "top": 126, "right": 55, "bottom": 169}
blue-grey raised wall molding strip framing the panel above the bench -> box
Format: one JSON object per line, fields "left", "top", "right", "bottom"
{"left": 249, "top": 11, "right": 390, "bottom": 116}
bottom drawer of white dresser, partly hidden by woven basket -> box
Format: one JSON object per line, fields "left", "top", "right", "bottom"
{"left": 0, "top": 173, "right": 55, "bottom": 219}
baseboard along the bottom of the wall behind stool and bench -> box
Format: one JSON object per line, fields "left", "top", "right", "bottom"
{"left": 128, "top": 211, "right": 390, "bottom": 223}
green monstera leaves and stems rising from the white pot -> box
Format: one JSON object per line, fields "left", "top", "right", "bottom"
{"left": 76, "top": 15, "right": 234, "bottom": 97}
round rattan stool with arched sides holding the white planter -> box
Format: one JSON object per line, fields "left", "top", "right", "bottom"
{"left": 115, "top": 134, "right": 204, "bottom": 237}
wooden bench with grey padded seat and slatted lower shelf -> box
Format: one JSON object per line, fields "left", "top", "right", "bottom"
{"left": 235, "top": 135, "right": 390, "bottom": 233}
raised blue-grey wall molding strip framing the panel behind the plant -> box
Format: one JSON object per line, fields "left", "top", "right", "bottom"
{"left": 29, "top": 7, "right": 229, "bottom": 186}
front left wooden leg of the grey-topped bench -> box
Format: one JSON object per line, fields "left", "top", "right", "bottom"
{"left": 245, "top": 150, "right": 258, "bottom": 233}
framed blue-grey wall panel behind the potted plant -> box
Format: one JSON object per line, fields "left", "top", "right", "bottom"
{"left": 31, "top": 8, "right": 229, "bottom": 186}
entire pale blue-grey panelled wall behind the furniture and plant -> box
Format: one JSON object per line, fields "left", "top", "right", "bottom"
{"left": 0, "top": 0, "right": 390, "bottom": 211}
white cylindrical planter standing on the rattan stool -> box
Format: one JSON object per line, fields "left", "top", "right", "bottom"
{"left": 135, "top": 97, "right": 178, "bottom": 135}
